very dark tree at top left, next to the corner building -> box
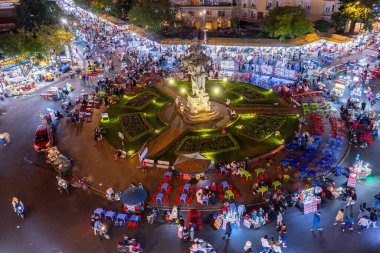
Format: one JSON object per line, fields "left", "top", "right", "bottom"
{"left": 16, "top": 0, "right": 61, "bottom": 32}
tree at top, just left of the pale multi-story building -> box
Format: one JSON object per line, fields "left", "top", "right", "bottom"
{"left": 128, "top": 0, "right": 178, "bottom": 33}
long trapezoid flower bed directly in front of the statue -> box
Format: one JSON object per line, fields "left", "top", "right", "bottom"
{"left": 176, "top": 134, "right": 239, "bottom": 154}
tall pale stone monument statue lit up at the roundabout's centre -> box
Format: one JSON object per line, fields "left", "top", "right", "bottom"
{"left": 184, "top": 39, "right": 211, "bottom": 114}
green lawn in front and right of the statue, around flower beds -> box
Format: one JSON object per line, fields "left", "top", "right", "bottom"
{"left": 156, "top": 115, "right": 298, "bottom": 162}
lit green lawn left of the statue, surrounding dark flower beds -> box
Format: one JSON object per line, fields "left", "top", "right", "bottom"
{"left": 101, "top": 88, "right": 170, "bottom": 153}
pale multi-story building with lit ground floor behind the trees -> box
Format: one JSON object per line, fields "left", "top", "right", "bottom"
{"left": 172, "top": 0, "right": 339, "bottom": 30}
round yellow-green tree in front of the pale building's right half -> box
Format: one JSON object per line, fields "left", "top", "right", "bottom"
{"left": 262, "top": 6, "right": 314, "bottom": 40}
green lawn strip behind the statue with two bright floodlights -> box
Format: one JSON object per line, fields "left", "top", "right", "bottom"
{"left": 168, "top": 80, "right": 280, "bottom": 107}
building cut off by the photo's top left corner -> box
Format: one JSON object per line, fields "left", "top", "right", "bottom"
{"left": 0, "top": 0, "right": 19, "bottom": 32}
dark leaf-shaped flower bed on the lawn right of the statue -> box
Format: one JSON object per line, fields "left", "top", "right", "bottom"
{"left": 238, "top": 115, "right": 286, "bottom": 141}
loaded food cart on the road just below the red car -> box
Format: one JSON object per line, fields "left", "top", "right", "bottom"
{"left": 45, "top": 146, "right": 72, "bottom": 176}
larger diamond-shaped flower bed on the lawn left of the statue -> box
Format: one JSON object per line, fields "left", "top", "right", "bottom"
{"left": 120, "top": 113, "right": 153, "bottom": 141}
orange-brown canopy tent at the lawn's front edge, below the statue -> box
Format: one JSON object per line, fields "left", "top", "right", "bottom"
{"left": 173, "top": 152, "right": 211, "bottom": 174}
